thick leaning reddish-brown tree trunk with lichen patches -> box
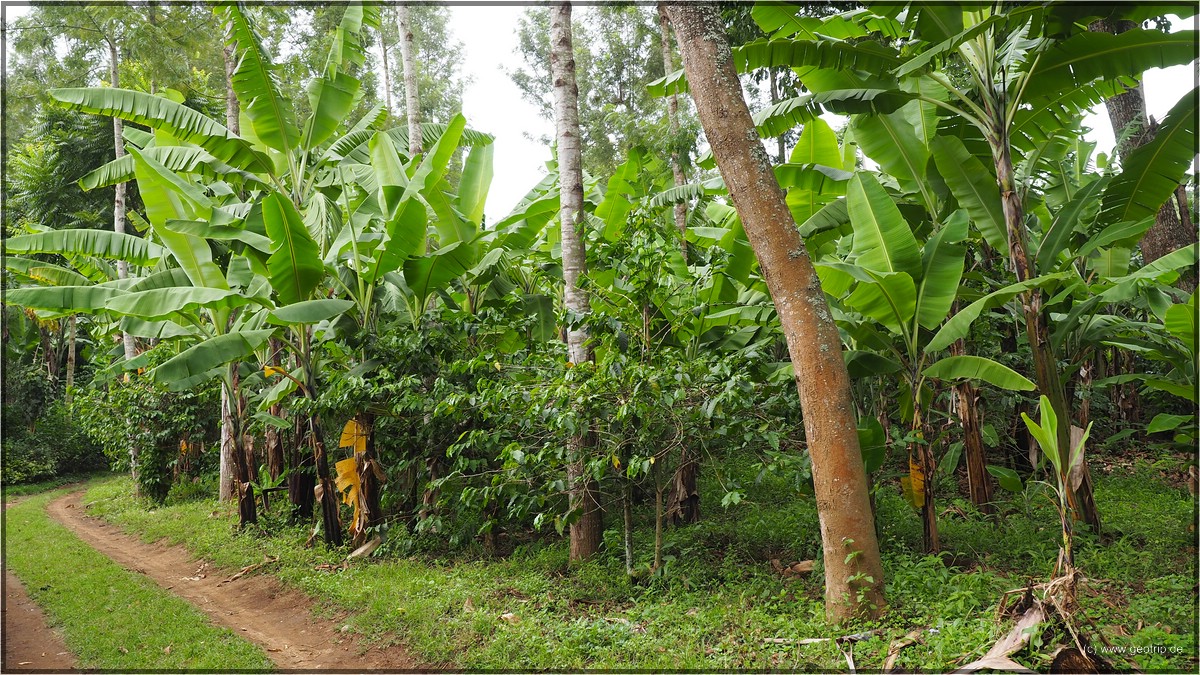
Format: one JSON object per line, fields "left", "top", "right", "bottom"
{"left": 661, "top": 4, "right": 884, "bottom": 622}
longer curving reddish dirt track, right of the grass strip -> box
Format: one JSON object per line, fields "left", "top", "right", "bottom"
{"left": 47, "top": 492, "right": 418, "bottom": 670}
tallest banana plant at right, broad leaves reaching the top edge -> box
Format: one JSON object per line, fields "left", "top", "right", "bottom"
{"left": 729, "top": 4, "right": 1196, "bottom": 527}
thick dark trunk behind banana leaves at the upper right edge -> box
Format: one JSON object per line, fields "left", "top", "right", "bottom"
{"left": 1088, "top": 19, "right": 1196, "bottom": 293}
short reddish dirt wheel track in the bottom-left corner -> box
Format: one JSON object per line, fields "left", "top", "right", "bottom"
{"left": 0, "top": 500, "right": 76, "bottom": 673}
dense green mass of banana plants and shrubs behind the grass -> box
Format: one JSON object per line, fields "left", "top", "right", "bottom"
{"left": 4, "top": 4, "right": 1200, "bottom": 667}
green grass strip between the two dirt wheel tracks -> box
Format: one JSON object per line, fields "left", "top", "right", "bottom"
{"left": 4, "top": 490, "right": 272, "bottom": 671}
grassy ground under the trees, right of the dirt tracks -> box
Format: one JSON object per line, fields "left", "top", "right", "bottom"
{"left": 77, "top": 465, "right": 1196, "bottom": 671}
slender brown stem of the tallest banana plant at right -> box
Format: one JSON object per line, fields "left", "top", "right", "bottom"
{"left": 989, "top": 131, "right": 1100, "bottom": 533}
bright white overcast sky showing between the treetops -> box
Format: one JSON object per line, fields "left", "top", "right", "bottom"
{"left": 5, "top": 0, "right": 1200, "bottom": 222}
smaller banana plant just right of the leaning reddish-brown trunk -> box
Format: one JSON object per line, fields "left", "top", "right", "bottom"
{"left": 816, "top": 172, "right": 1034, "bottom": 551}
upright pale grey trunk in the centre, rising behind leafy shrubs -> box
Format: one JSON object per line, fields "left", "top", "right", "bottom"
{"left": 550, "top": 2, "right": 604, "bottom": 561}
